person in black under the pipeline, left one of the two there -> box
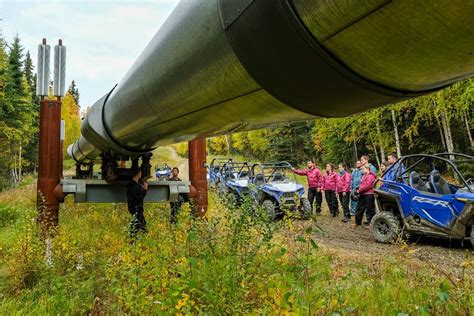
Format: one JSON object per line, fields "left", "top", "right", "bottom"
{"left": 127, "top": 168, "right": 148, "bottom": 238}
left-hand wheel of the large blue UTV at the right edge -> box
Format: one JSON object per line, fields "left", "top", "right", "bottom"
{"left": 371, "top": 212, "right": 400, "bottom": 244}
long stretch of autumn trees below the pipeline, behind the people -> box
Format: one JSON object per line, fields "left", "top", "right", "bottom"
{"left": 199, "top": 79, "right": 474, "bottom": 166}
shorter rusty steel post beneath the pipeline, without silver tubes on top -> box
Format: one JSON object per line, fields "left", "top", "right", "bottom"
{"left": 188, "top": 138, "right": 207, "bottom": 217}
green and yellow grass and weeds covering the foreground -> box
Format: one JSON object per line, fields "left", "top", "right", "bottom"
{"left": 0, "top": 187, "right": 474, "bottom": 315}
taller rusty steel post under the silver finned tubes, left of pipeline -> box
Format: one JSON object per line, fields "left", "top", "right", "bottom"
{"left": 36, "top": 99, "right": 62, "bottom": 232}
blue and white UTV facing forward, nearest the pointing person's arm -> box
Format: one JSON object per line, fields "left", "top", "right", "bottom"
{"left": 251, "top": 161, "right": 311, "bottom": 219}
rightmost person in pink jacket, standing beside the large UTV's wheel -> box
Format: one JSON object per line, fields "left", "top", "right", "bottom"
{"left": 355, "top": 165, "right": 377, "bottom": 227}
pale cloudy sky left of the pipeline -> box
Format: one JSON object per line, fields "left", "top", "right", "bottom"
{"left": 0, "top": 0, "right": 179, "bottom": 109}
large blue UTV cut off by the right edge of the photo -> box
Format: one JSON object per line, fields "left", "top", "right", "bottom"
{"left": 371, "top": 153, "right": 474, "bottom": 245}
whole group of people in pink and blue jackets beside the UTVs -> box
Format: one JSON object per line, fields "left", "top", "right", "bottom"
{"left": 293, "top": 153, "right": 401, "bottom": 227}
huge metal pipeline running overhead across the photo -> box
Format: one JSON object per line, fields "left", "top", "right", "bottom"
{"left": 68, "top": 0, "right": 474, "bottom": 164}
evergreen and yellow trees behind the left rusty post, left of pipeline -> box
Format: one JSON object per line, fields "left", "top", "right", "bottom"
{"left": 0, "top": 35, "right": 80, "bottom": 190}
